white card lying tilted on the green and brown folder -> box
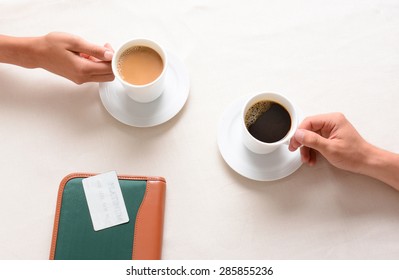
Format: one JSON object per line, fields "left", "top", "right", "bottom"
{"left": 82, "top": 171, "right": 129, "bottom": 231}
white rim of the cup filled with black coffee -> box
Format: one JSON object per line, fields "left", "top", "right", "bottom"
{"left": 241, "top": 92, "right": 298, "bottom": 147}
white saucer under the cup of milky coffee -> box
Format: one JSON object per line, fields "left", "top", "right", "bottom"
{"left": 99, "top": 53, "right": 190, "bottom": 127}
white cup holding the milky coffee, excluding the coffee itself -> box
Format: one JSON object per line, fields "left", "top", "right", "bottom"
{"left": 112, "top": 38, "right": 168, "bottom": 103}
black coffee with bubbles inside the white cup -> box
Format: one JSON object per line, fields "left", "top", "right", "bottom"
{"left": 245, "top": 101, "right": 291, "bottom": 143}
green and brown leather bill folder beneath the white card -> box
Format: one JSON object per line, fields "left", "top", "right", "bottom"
{"left": 50, "top": 173, "right": 166, "bottom": 260}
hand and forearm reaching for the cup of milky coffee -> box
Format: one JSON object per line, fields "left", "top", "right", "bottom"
{"left": 0, "top": 32, "right": 114, "bottom": 84}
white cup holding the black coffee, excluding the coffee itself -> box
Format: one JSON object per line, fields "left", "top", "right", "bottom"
{"left": 241, "top": 93, "right": 298, "bottom": 154}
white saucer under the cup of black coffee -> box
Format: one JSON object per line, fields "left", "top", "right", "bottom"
{"left": 218, "top": 97, "right": 302, "bottom": 181}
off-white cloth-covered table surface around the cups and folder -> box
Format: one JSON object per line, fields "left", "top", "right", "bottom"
{"left": 0, "top": 0, "right": 399, "bottom": 259}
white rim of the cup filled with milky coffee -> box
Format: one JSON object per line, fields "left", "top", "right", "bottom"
{"left": 111, "top": 37, "right": 168, "bottom": 88}
